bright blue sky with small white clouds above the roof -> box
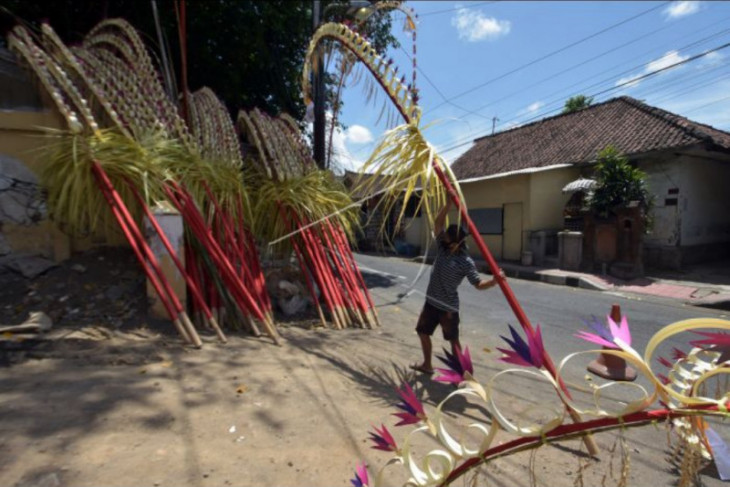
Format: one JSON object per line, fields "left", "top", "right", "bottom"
{"left": 328, "top": 1, "right": 730, "bottom": 173}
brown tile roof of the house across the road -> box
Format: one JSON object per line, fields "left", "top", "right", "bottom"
{"left": 451, "top": 96, "right": 730, "bottom": 179}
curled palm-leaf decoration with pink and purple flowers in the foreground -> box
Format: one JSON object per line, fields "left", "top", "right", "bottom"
{"left": 346, "top": 318, "right": 730, "bottom": 487}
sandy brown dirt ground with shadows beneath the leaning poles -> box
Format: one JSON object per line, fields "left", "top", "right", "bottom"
{"left": 0, "top": 253, "right": 721, "bottom": 487}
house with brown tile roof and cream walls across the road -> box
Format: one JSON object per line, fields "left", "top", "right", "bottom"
{"left": 452, "top": 96, "right": 730, "bottom": 269}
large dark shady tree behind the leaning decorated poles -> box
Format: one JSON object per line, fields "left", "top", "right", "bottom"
{"left": 0, "top": 0, "right": 398, "bottom": 119}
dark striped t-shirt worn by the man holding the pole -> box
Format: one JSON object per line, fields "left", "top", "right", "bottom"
{"left": 426, "top": 232, "right": 481, "bottom": 312}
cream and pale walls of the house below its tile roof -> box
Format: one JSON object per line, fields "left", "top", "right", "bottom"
{"left": 404, "top": 149, "right": 730, "bottom": 268}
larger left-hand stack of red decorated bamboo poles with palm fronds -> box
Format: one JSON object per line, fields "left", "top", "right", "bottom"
{"left": 9, "top": 19, "right": 279, "bottom": 347}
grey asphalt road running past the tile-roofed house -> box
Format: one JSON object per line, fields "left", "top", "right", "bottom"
{"left": 356, "top": 255, "right": 728, "bottom": 394}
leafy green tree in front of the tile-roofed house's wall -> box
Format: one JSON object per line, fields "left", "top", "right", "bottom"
{"left": 588, "top": 146, "right": 653, "bottom": 228}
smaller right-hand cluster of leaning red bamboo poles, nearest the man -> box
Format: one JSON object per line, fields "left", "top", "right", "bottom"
{"left": 238, "top": 109, "right": 379, "bottom": 329}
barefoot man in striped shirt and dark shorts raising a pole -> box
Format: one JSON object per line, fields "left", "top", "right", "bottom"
{"left": 411, "top": 200, "right": 504, "bottom": 374}
